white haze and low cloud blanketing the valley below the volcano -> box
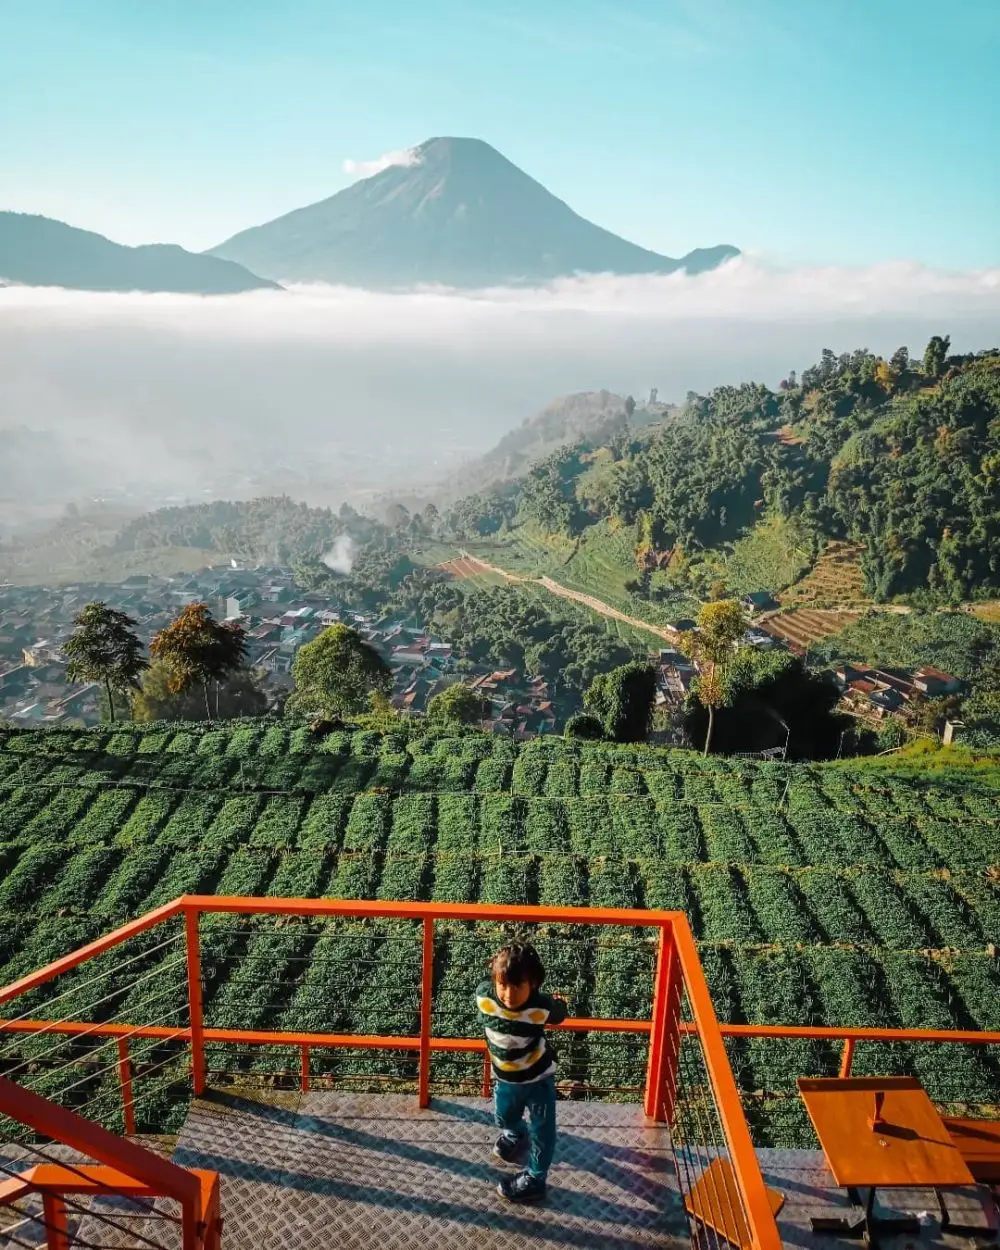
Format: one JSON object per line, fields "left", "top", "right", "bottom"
{"left": 0, "top": 259, "right": 1000, "bottom": 529}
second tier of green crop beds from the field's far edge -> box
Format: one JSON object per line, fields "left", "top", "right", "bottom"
{"left": 0, "top": 780, "right": 1000, "bottom": 873}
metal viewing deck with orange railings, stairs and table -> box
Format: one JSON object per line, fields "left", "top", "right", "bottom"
{"left": 0, "top": 895, "right": 1000, "bottom": 1250}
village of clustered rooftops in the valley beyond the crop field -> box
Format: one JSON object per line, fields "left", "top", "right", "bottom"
{"left": 0, "top": 566, "right": 963, "bottom": 741}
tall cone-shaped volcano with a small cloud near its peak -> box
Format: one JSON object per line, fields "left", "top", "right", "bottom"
{"left": 211, "top": 139, "right": 738, "bottom": 288}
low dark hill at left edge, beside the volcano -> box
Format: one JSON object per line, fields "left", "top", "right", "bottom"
{"left": 0, "top": 213, "right": 279, "bottom": 295}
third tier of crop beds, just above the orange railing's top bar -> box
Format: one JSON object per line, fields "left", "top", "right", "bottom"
{"left": 0, "top": 845, "right": 1000, "bottom": 980}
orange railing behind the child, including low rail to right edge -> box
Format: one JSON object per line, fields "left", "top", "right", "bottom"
{"left": 7, "top": 895, "right": 1000, "bottom": 1250}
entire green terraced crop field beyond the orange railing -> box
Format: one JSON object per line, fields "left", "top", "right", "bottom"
{"left": 0, "top": 723, "right": 1000, "bottom": 1144}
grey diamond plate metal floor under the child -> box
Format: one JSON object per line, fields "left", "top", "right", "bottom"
{"left": 174, "top": 1093, "right": 690, "bottom": 1250}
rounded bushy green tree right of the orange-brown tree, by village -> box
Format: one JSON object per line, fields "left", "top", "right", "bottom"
{"left": 288, "top": 625, "right": 393, "bottom": 716}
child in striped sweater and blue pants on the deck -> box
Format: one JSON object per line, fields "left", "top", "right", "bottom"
{"left": 476, "top": 943, "right": 566, "bottom": 1203}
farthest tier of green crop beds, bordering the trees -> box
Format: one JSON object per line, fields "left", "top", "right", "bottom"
{"left": 0, "top": 725, "right": 1000, "bottom": 821}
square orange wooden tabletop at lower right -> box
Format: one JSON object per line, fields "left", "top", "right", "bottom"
{"left": 796, "top": 1076, "right": 975, "bottom": 1189}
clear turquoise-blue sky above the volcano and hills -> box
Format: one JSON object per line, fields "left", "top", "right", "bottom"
{"left": 0, "top": 0, "right": 1000, "bottom": 268}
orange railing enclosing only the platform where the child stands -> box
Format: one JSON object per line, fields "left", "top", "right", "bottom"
{"left": 0, "top": 895, "right": 780, "bottom": 1250}
